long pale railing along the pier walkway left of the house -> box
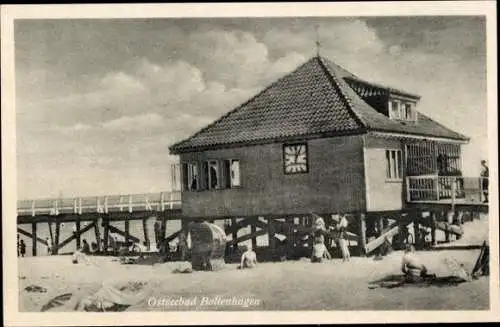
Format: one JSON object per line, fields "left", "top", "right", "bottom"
{"left": 17, "top": 192, "right": 181, "bottom": 216}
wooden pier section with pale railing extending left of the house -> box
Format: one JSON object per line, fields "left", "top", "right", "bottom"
{"left": 17, "top": 192, "right": 181, "bottom": 256}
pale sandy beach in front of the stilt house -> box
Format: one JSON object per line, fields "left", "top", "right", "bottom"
{"left": 19, "top": 246, "right": 489, "bottom": 311}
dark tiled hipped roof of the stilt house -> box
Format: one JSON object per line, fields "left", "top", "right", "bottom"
{"left": 170, "top": 57, "right": 467, "bottom": 154}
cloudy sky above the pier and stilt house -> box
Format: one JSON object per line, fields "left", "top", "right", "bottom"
{"left": 14, "top": 16, "right": 488, "bottom": 199}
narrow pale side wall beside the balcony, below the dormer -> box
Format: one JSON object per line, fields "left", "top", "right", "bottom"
{"left": 364, "top": 136, "right": 405, "bottom": 211}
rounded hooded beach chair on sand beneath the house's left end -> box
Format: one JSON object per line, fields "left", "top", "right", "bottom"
{"left": 190, "top": 222, "right": 226, "bottom": 271}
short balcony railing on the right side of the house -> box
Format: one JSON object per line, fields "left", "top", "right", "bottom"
{"left": 406, "top": 175, "right": 488, "bottom": 202}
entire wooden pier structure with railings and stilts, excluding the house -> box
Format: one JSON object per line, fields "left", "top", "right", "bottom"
{"left": 17, "top": 176, "right": 488, "bottom": 260}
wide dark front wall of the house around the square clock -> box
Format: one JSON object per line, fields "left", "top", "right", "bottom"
{"left": 180, "top": 136, "right": 366, "bottom": 217}
